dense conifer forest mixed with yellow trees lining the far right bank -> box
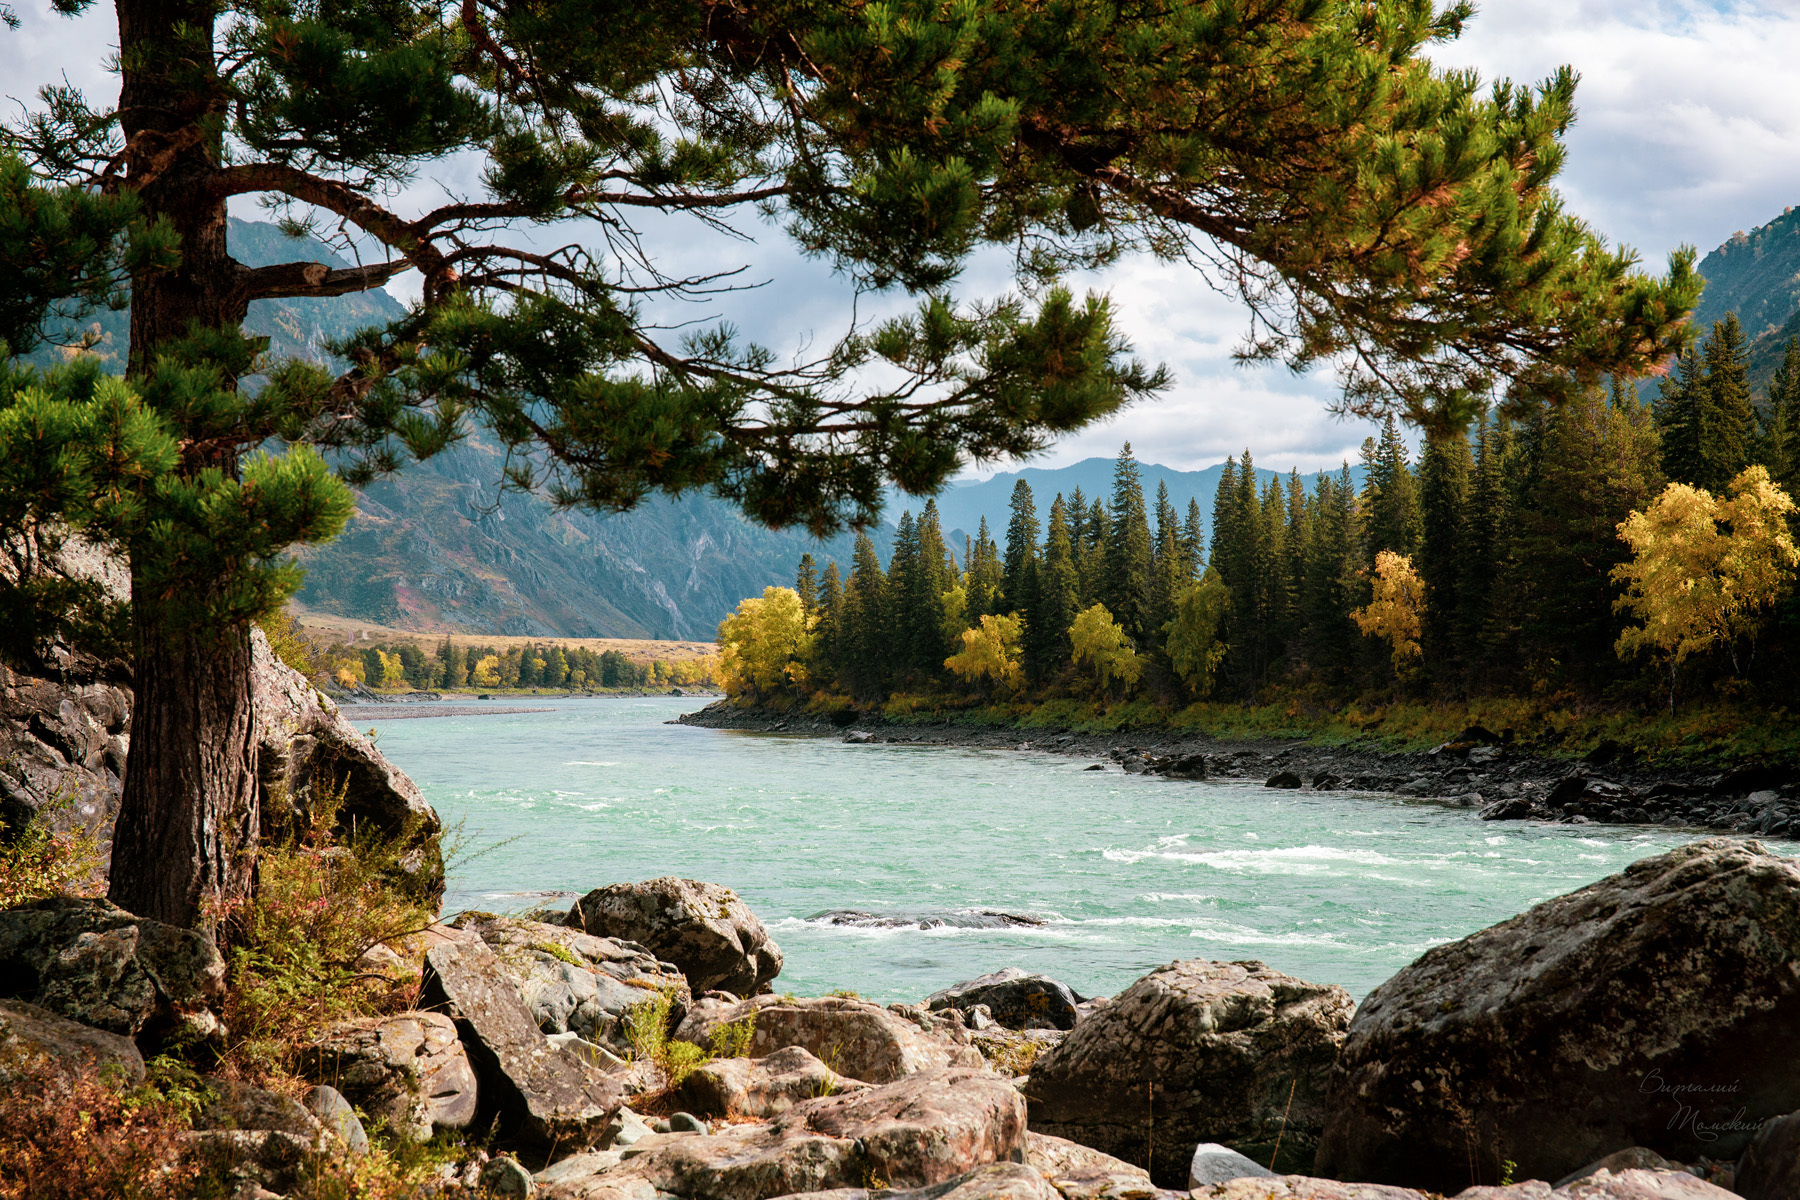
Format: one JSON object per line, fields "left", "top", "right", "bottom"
{"left": 720, "top": 317, "right": 1800, "bottom": 705}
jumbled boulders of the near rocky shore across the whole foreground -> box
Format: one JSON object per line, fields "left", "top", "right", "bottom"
{"left": 0, "top": 838, "right": 1800, "bottom": 1200}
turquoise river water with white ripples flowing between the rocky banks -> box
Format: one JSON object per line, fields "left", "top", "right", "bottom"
{"left": 369, "top": 696, "right": 1688, "bottom": 1000}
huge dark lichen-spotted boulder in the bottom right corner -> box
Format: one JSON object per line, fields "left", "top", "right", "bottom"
{"left": 1317, "top": 838, "right": 1800, "bottom": 1191}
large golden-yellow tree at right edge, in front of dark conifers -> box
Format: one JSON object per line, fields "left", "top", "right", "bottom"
{"left": 1613, "top": 466, "right": 1800, "bottom": 712}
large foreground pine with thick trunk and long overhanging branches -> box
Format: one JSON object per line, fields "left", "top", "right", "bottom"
{"left": 0, "top": 0, "right": 1699, "bottom": 923}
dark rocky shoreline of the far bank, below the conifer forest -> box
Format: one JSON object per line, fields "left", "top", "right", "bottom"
{"left": 677, "top": 702, "right": 1800, "bottom": 838}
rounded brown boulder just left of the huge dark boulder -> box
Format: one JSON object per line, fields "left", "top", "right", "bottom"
{"left": 1024, "top": 959, "right": 1354, "bottom": 1187}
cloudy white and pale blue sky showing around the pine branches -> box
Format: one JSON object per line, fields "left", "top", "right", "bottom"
{"left": 0, "top": 0, "right": 1800, "bottom": 473}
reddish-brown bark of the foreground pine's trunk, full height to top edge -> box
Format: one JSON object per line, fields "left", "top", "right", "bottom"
{"left": 110, "top": 0, "right": 257, "bottom": 930}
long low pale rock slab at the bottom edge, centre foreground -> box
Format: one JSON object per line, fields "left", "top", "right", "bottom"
{"left": 538, "top": 1067, "right": 1042, "bottom": 1200}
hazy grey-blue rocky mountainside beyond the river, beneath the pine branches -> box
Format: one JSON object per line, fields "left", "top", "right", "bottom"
{"left": 299, "top": 434, "right": 887, "bottom": 640}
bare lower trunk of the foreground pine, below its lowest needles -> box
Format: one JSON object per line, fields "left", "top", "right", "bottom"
{"left": 110, "top": 603, "right": 257, "bottom": 930}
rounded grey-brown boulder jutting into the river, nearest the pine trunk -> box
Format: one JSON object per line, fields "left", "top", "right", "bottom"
{"left": 569, "top": 876, "right": 781, "bottom": 995}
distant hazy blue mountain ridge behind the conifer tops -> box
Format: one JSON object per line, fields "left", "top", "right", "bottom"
{"left": 884, "top": 459, "right": 1363, "bottom": 556}
